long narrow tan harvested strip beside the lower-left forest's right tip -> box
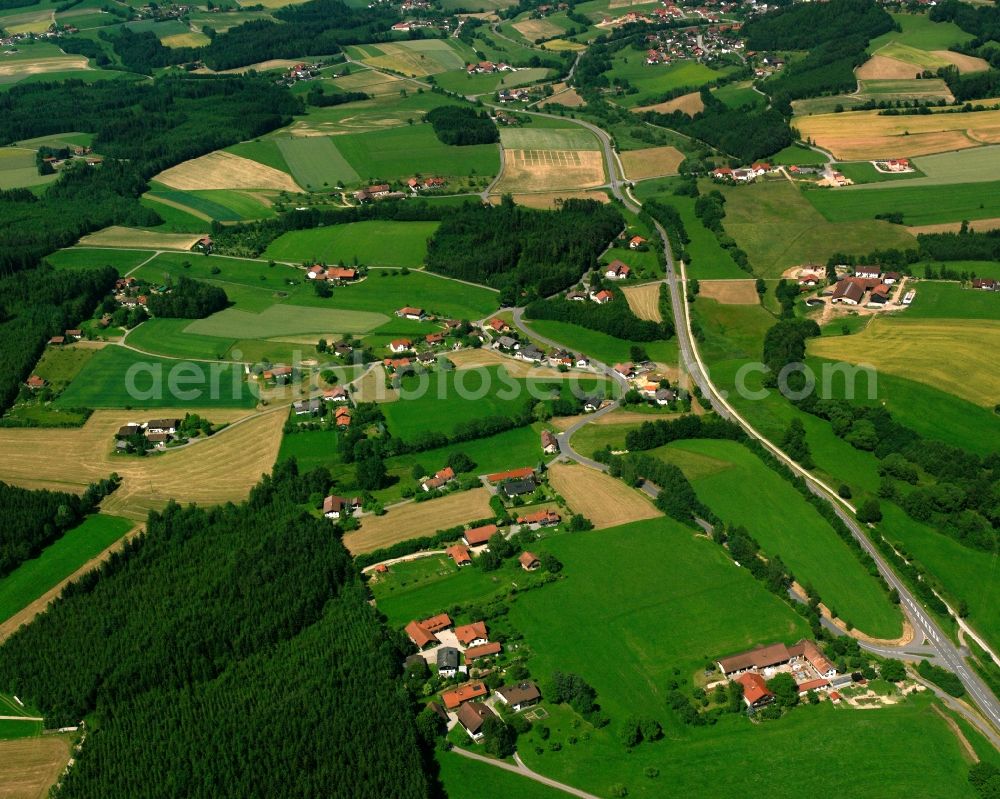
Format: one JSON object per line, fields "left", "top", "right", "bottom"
{"left": 344, "top": 488, "right": 493, "bottom": 555}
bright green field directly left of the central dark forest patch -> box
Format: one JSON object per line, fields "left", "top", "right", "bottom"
{"left": 263, "top": 221, "right": 438, "bottom": 267}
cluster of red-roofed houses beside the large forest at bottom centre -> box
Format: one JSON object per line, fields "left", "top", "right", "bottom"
{"left": 406, "top": 620, "right": 542, "bottom": 742}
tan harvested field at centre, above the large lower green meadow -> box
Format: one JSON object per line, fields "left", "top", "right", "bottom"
{"left": 549, "top": 463, "right": 663, "bottom": 530}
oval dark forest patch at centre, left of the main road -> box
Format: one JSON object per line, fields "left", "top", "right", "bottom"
{"left": 427, "top": 197, "right": 624, "bottom": 304}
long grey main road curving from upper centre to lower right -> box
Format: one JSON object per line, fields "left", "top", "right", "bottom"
{"left": 515, "top": 104, "right": 1000, "bottom": 729}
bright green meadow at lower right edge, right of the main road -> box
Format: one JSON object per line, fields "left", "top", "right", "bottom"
{"left": 879, "top": 502, "right": 1000, "bottom": 648}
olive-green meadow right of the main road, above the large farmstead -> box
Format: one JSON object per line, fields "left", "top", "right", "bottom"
{"left": 722, "top": 180, "right": 916, "bottom": 277}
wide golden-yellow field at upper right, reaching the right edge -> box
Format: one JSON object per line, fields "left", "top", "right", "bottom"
{"left": 793, "top": 111, "right": 1000, "bottom": 160}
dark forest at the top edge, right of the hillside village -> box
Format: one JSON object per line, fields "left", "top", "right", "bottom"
{"left": 743, "top": 0, "right": 896, "bottom": 108}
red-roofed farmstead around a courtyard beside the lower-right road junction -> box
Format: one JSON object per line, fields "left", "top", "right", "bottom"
{"left": 717, "top": 639, "right": 854, "bottom": 710}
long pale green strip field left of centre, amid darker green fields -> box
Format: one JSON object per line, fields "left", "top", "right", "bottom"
{"left": 184, "top": 305, "right": 386, "bottom": 339}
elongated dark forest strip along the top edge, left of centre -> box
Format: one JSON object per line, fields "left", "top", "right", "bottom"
{"left": 100, "top": 0, "right": 399, "bottom": 75}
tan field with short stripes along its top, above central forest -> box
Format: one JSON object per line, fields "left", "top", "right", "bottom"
{"left": 496, "top": 150, "right": 605, "bottom": 194}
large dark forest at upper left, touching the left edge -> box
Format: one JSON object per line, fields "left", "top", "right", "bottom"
{"left": 0, "top": 76, "right": 300, "bottom": 273}
